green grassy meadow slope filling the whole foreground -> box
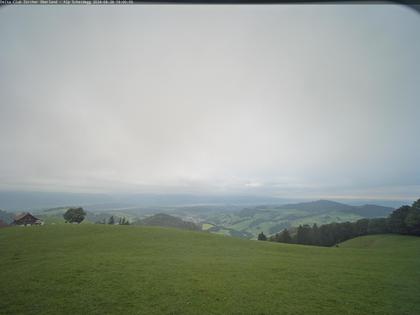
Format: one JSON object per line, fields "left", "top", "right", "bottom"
{"left": 0, "top": 225, "right": 420, "bottom": 315}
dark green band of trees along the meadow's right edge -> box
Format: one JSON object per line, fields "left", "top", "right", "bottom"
{"left": 258, "top": 199, "right": 420, "bottom": 246}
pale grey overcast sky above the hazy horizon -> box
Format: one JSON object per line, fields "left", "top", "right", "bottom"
{"left": 0, "top": 5, "right": 420, "bottom": 199}
